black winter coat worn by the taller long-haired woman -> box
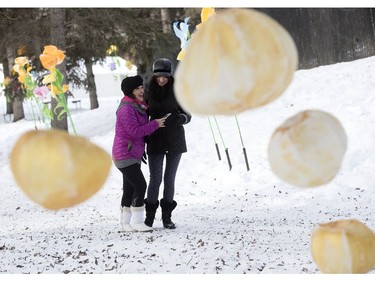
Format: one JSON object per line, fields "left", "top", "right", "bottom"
{"left": 145, "top": 76, "right": 191, "bottom": 154}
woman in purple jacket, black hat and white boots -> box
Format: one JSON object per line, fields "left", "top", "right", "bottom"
{"left": 112, "top": 75, "right": 165, "bottom": 231}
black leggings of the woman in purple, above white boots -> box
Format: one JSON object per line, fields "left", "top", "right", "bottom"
{"left": 118, "top": 164, "right": 147, "bottom": 207}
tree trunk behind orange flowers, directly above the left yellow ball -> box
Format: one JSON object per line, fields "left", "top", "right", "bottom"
{"left": 50, "top": 8, "right": 68, "bottom": 131}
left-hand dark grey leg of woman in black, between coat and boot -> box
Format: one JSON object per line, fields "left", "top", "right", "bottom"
{"left": 147, "top": 153, "right": 164, "bottom": 204}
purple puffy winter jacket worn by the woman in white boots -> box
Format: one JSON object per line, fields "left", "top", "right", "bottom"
{"left": 112, "top": 97, "right": 159, "bottom": 160}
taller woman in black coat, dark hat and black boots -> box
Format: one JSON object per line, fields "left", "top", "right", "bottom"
{"left": 145, "top": 58, "right": 191, "bottom": 229}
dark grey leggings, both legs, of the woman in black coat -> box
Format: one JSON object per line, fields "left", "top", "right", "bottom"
{"left": 147, "top": 153, "right": 182, "bottom": 204}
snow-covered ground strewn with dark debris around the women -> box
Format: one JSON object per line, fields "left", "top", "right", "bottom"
{"left": 0, "top": 57, "right": 375, "bottom": 278}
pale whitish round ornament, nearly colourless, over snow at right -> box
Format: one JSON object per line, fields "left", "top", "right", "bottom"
{"left": 268, "top": 110, "right": 347, "bottom": 187}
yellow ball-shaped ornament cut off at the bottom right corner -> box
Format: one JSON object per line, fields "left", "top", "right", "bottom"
{"left": 310, "top": 219, "right": 375, "bottom": 274}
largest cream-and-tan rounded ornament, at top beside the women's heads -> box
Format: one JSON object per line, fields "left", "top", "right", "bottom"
{"left": 175, "top": 9, "right": 298, "bottom": 115}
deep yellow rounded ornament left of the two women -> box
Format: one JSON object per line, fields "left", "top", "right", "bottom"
{"left": 10, "top": 130, "right": 112, "bottom": 210}
